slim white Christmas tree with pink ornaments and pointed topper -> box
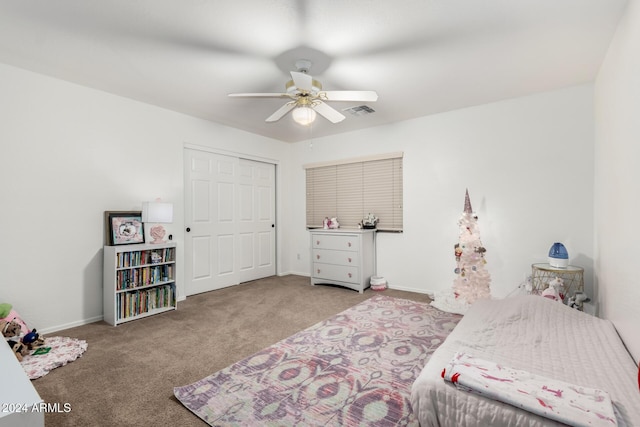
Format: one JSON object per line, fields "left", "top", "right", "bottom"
{"left": 453, "top": 190, "right": 491, "bottom": 304}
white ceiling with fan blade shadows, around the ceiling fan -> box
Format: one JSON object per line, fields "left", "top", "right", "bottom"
{"left": 0, "top": 0, "right": 627, "bottom": 142}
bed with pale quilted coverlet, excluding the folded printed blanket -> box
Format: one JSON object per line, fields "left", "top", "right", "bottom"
{"left": 411, "top": 295, "right": 640, "bottom": 427}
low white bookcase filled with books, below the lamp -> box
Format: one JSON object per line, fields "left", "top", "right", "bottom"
{"left": 103, "top": 243, "right": 177, "bottom": 326}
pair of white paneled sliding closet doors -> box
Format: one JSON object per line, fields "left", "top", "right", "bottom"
{"left": 185, "top": 148, "right": 275, "bottom": 295}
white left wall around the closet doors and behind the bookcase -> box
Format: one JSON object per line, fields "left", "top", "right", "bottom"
{"left": 0, "top": 64, "right": 290, "bottom": 332}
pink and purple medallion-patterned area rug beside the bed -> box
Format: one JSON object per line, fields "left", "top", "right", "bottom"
{"left": 174, "top": 296, "right": 462, "bottom": 426}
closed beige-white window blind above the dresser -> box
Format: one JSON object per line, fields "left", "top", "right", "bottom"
{"left": 305, "top": 153, "right": 403, "bottom": 231}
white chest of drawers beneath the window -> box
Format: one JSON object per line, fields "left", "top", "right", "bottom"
{"left": 309, "top": 229, "right": 376, "bottom": 293}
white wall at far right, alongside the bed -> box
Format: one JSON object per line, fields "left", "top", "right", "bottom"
{"left": 595, "top": 0, "right": 640, "bottom": 361}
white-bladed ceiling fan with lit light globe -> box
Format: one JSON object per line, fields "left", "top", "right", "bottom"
{"left": 229, "top": 59, "right": 378, "bottom": 125}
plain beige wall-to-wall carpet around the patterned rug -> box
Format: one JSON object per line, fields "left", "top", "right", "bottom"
{"left": 33, "top": 276, "right": 430, "bottom": 427}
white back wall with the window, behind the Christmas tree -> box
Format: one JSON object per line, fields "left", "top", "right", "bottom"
{"left": 290, "top": 85, "right": 594, "bottom": 297}
